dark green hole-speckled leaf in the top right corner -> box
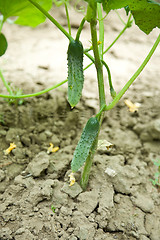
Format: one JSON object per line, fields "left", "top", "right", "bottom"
{"left": 102, "top": 0, "right": 160, "bottom": 34}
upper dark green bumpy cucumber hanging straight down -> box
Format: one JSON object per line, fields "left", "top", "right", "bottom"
{"left": 67, "top": 40, "right": 84, "bottom": 108}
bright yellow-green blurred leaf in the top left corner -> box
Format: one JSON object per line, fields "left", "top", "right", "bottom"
{"left": 0, "top": 0, "right": 52, "bottom": 27}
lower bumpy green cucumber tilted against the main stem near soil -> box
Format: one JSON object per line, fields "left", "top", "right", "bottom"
{"left": 71, "top": 117, "right": 100, "bottom": 172}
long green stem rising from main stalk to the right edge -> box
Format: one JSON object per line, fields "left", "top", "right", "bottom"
{"left": 105, "top": 34, "right": 160, "bottom": 111}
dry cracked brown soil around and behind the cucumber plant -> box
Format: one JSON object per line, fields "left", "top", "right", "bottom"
{"left": 0, "top": 4, "right": 160, "bottom": 240}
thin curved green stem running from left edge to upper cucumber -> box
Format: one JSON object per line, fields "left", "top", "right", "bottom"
{"left": 0, "top": 80, "right": 68, "bottom": 99}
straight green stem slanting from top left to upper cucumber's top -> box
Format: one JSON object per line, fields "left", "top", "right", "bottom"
{"left": 28, "top": 0, "right": 74, "bottom": 41}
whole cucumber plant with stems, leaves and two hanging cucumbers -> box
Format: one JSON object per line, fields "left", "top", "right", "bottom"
{"left": 0, "top": 0, "right": 160, "bottom": 190}
